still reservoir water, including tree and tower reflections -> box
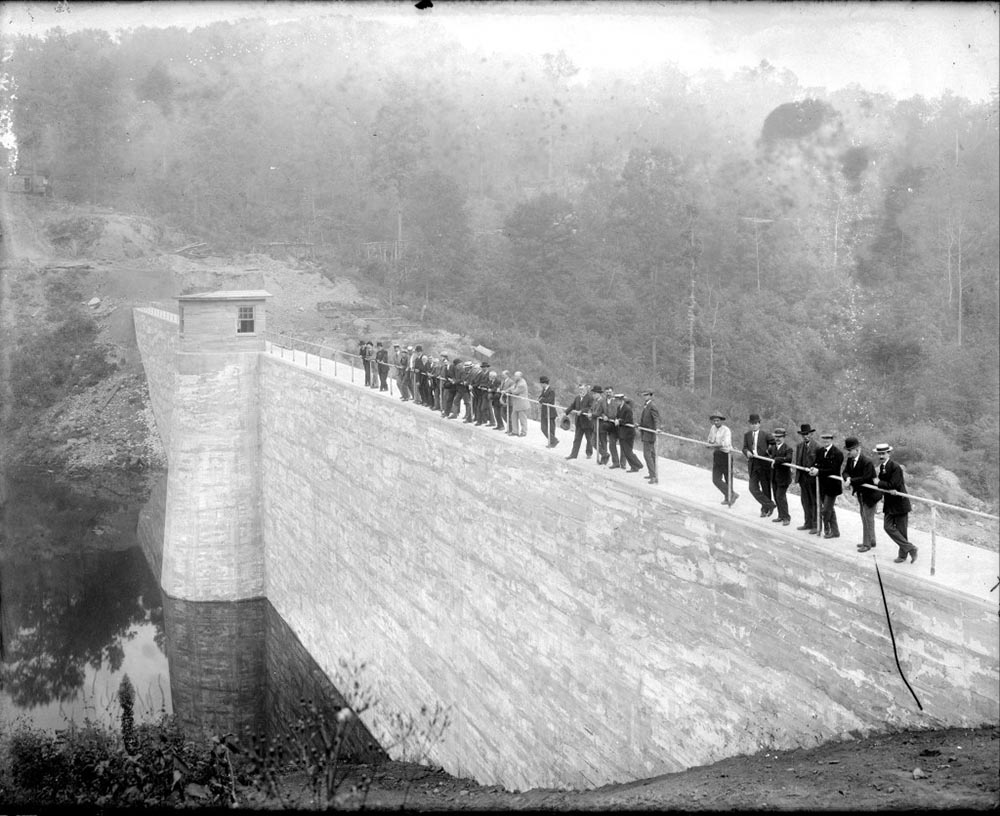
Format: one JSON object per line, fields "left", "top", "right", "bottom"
{"left": 0, "top": 471, "right": 370, "bottom": 741}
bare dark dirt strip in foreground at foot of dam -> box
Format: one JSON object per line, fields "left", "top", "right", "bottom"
{"left": 244, "top": 727, "right": 1000, "bottom": 811}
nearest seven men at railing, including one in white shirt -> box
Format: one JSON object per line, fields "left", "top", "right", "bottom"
{"left": 707, "top": 413, "right": 917, "bottom": 564}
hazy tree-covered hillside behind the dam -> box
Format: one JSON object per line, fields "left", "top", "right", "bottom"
{"left": 5, "top": 14, "right": 1000, "bottom": 505}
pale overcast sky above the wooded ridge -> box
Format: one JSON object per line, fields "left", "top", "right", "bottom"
{"left": 3, "top": 0, "right": 1000, "bottom": 100}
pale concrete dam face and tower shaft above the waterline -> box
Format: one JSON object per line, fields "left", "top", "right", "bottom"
{"left": 137, "top": 310, "right": 1000, "bottom": 789}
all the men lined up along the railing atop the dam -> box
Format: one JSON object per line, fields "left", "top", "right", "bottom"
{"left": 359, "top": 341, "right": 917, "bottom": 563}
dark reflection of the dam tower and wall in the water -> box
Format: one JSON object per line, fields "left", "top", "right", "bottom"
{"left": 139, "top": 468, "right": 387, "bottom": 762}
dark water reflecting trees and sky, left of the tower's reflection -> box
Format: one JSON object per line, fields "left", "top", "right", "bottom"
{"left": 0, "top": 473, "right": 170, "bottom": 728}
